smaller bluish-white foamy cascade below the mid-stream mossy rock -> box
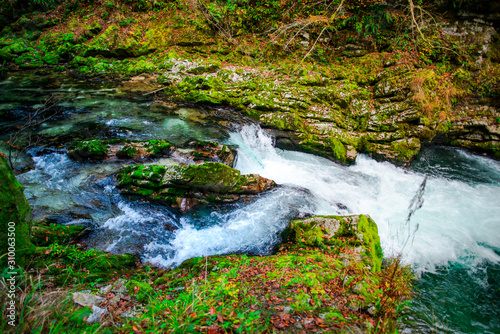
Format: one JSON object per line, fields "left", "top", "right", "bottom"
{"left": 144, "top": 188, "right": 313, "bottom": 267}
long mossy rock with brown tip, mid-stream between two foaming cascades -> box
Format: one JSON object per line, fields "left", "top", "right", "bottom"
{"left": 117, "top": 162, "right": 276, "bottom": 212}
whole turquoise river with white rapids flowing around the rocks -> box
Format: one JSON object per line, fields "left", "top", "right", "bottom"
{"left": 0, "top": 76, "right": 500, "bottom": 333}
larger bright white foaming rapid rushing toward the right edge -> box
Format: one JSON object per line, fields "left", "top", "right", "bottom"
{"left": 231, "top": 126, "right": 500, "bottom": 270}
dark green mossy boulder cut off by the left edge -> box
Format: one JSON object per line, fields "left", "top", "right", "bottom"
{"left": 0, "top": 154, "right": 35, "bottom": 270}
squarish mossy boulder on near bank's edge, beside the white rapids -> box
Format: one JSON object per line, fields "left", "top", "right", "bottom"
{"left": 285, "top": 215, "right": 383, "bottom": 272}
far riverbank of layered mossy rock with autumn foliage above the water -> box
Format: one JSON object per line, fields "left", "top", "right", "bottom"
{"left": 0, "top": 2, "right": 500, "bottom": 165}
